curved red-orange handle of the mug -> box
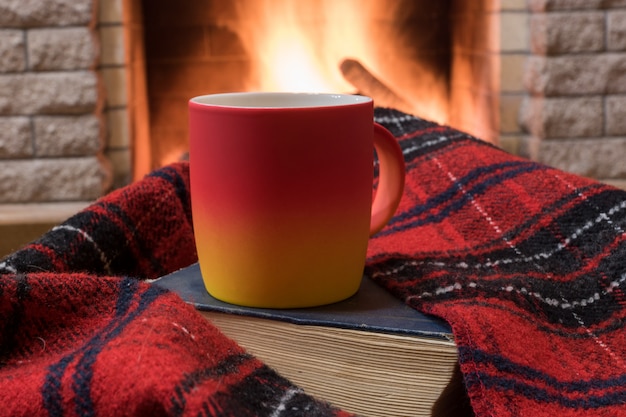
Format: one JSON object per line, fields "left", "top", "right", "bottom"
{"left": 370, "top": 123, "right": 405, "bottom": 236}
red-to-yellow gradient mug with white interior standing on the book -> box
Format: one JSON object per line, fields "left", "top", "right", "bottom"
{"left": 189, "top": 93, "right": 404, "bottom": 308}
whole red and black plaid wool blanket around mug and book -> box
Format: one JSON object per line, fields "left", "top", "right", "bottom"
{"left": 0, "top": 109, "right": 626, "bottom": 417}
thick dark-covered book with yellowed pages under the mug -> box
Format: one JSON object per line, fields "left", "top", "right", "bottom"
{"left": 155, "top": 263, "right": 457, "bottom": 417}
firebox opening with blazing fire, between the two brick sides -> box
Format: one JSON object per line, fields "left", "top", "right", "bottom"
{"left": 129, "top": 0, "right": 498, "bottom": 178}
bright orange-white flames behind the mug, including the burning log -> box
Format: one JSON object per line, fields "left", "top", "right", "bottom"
{"left": 222, "top": 0, "right": 448, "bottom": 123}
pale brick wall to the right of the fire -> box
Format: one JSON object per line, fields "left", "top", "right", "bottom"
{"left": 520, "top": 0, "right": 626, "bottom": 187}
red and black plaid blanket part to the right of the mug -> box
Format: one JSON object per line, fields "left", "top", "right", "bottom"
{"left": 366, "top": 110, "right": 626, "bottom": 417}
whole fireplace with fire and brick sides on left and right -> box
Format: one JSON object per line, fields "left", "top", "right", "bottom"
{"left": 0, "top": 0, "right": 626, "bottom": 239}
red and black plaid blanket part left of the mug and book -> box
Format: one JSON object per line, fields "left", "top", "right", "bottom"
{"left": 0, "top": 163, "right": 348, "bottom": 417}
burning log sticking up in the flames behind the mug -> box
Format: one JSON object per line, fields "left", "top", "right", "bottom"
{"left": 339, "top": 58, "right": 413, "bottom": 113}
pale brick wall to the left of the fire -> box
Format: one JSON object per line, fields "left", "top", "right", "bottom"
{"left": 0, "top": 0, "right": 110, "bottom": 203}
